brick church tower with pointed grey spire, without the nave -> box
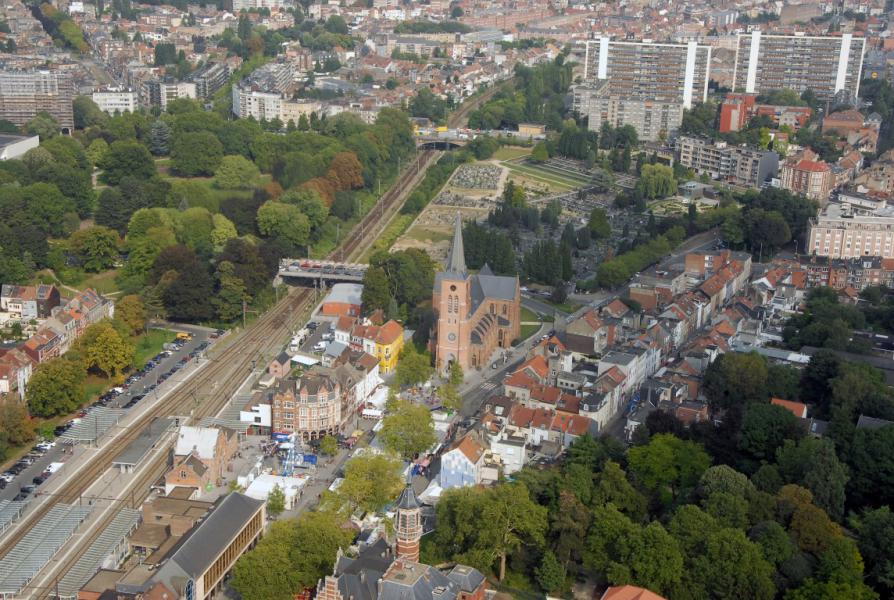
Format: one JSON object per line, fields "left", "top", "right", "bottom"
{"left": 435, "top": 213, "right": 471, "bottom": 373}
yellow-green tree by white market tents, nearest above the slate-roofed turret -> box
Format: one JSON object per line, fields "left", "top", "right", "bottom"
{"left": 334, "top": 454, "right": 403, "bottom": 513}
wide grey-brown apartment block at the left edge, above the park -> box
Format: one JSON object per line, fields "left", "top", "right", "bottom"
{"left": 0, "top": 71, "right": 74, "bottom": 133}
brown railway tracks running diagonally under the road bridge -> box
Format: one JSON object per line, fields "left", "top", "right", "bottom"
{"left": 9, "top": 136, "right": 448, "bottom": 598}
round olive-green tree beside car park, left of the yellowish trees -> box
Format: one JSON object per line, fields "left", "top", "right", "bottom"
{"left": 25, "top": 358, "right": 86, "bottom": 417}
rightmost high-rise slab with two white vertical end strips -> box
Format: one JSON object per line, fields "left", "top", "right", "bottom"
{"left": 733, "top": 31, "right": 866, "bottom": 101}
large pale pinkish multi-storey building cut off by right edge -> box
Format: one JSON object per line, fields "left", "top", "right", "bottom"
{"left": 807, "top": 203, "right": 894, "bottom": 258}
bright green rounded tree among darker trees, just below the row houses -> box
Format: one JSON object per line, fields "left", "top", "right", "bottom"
{"left": 628, "top": 433, "right": 711, "bottom": 503}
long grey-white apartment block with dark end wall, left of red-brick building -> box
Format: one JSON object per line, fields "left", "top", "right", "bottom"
{"left": 677, "top": 136, "right": 779, "bottom": 187}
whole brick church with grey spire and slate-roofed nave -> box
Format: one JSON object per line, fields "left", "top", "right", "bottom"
{"left": 432, "top": 214, "right": 521, "bottom": 374}
